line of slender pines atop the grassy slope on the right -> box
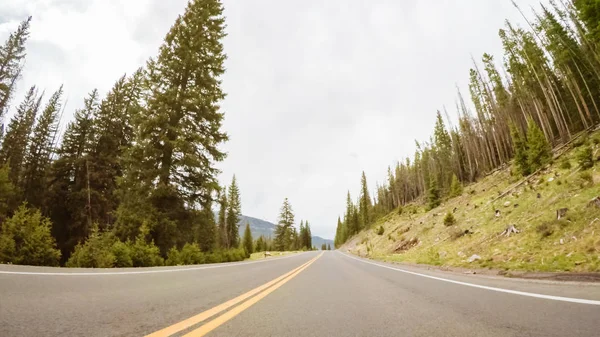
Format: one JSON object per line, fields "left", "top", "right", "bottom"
{"left": 335, "top": 0, "right": 600, "bottom": 246}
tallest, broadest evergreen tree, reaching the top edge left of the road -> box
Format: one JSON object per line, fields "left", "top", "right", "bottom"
{"left": 116, "top": 0, "right": 229, "bottom": 255}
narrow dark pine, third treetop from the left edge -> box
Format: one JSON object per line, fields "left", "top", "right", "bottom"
{"left": 21, "top": 86, "right": 63, "bottom": 207}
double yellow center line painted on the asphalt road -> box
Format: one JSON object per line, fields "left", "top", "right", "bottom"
{"left": 146, "top": 253, "right": 323, "bottom": 337}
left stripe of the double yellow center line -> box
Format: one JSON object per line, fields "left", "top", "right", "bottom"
{"left": 145, "top": 256, "right": 319, "bottom": 337}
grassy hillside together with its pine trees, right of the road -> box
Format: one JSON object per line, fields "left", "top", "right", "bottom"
{"left": 335, "top": 0, "right": 600, "bottom": 271}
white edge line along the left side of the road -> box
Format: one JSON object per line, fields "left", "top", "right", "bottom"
{"left": 0, "top": 253, "right": 304, "bottom": 276}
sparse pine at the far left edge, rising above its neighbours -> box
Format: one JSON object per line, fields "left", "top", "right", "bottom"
{"left": 0, "top": 17, "right": 31, "bottom": 126}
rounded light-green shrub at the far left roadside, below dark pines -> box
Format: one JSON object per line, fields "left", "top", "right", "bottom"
{"left": 0, "top": 204, "right": 61, "bottom": 266}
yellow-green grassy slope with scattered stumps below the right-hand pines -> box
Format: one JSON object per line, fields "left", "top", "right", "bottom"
{"left": 342, "top": 134, "right": 600, "bottom": 272}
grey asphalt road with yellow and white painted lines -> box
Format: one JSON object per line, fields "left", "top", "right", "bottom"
{"left": 0, "top": 252, "right": 600, "bottom": 337}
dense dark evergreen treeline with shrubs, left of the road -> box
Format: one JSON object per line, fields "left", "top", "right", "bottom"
{"left": 0, "top": 0, "right": 312, "bottom": 267}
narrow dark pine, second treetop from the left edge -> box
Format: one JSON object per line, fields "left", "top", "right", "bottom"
{"left": 0, "top": 86, "right": 42, "bottom": 186}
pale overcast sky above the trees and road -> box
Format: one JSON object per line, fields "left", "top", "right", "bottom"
{"left": 0, "top": 0, "right": 537, "bottom": 238}
